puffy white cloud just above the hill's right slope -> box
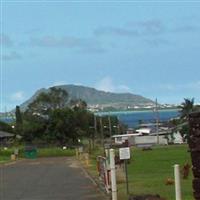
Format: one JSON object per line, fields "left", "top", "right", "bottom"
{"left": 95, "top": 76, "right": 131, "bottom": 93}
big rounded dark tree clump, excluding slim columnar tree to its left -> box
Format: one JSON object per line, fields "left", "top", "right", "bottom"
{"left": 21, "top": 88, "right": 93, "bottom": 144}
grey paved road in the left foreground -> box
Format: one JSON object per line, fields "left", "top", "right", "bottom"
{"left": 0, "top": 158, "right": 108, "bottom": 200}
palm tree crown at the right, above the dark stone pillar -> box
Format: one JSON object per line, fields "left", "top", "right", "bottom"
{"left": 179, "top": 98, "right": 195, "bottom": 119}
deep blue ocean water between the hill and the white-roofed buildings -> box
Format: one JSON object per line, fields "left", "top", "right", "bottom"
{"left": 97, "top": 110, "right": 180, "bottom": 127}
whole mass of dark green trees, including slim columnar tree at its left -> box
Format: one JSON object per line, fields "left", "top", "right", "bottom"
{"left": 10, "top": 87, "right": 121, "bottom": 145}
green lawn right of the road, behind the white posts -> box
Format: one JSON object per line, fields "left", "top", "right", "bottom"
{"left": 86, "top": 145, "right": 194, "bottom": 200}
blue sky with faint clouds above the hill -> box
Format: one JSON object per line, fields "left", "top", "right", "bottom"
{"left": 0, "top": 0, "right": 200, "bottom": 111}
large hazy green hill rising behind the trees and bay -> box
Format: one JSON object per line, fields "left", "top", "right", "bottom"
{"left": 20, "top": 85, "right": 154, "bottom": 110}
